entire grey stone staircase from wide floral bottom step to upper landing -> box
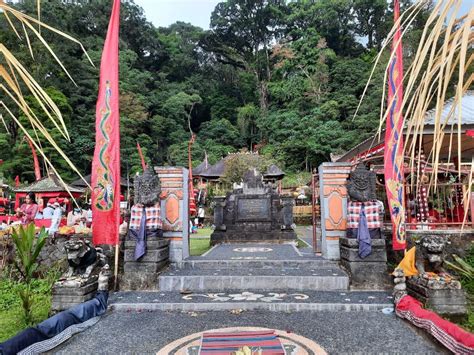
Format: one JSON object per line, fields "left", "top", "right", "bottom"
{"left": 111, "top": 244, "right": 392, "bottom": 312}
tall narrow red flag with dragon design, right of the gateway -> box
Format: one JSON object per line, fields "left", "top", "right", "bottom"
{"left": 384, "top": 0, "right": 406, "bottom": 250}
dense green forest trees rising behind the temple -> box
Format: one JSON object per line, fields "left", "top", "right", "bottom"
{"left": 0, "top": 0, "right": 434, "bottom": 182}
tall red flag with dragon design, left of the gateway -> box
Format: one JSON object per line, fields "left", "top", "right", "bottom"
{"left": 91, "top": 0, "right": 120, "bottom": 245}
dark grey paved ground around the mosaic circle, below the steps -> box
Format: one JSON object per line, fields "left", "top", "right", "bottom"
{"left": 52, "top": 311, "right": 446, "bottom": 354}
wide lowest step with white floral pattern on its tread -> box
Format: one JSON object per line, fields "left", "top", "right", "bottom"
{"left": 109, "top": 290, "right": 393, "bottom": 312}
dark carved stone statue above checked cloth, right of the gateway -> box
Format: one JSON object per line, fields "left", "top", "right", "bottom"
{"left": 347, "top": 164, "right": 377, "bottom": 202}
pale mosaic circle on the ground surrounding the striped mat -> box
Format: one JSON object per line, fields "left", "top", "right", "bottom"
{"left": 157, "top": 327, "right": 327, "bottom": 355}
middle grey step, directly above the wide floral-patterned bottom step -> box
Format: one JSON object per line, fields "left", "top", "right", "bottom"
{"left": 158, "top": 267, "right": 349, "bottom": 291}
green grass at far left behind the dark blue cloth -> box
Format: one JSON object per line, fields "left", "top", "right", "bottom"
{"left": 0, "top": 278, "right": 51, "bottom": 342}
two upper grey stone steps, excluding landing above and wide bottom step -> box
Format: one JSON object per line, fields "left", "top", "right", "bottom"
{"left": 158, "top": 260, "right": 349, "bottom": 292}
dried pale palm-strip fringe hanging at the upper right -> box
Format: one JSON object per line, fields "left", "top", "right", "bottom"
{"left": 354, "top": 0, "right": 474, "bottom": 198}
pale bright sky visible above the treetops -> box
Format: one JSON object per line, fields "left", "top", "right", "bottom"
{"left": 135, "top": 0, "right": 474, "bottom": 30}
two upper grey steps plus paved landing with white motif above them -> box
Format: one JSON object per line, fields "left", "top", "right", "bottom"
{"left": 158, "top": 243, "right": 349, "bottom": 292}
